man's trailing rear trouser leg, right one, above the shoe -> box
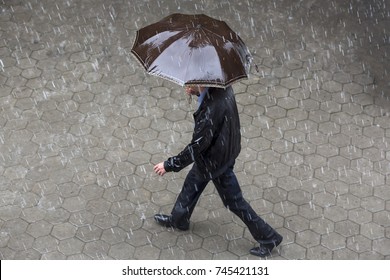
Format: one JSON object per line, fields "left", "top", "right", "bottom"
{"left": 213, "top": 167, "right": 278, "bottom": 247}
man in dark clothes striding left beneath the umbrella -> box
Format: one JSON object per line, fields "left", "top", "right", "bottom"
{"left": 154, "top": 86, "right": 283, "bottom": 257}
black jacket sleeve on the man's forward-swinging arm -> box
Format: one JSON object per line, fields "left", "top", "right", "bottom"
{"left": 164, "top": 107, "right": 219, "bottom": 172}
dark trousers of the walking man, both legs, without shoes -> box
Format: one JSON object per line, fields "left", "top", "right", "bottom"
{"left": 171, "top": 163, "right": 276, "bottom": 244}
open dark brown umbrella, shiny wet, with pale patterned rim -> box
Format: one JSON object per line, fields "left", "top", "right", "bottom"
{"left": 131, "top": 14, "right": 252, "bottom": 88}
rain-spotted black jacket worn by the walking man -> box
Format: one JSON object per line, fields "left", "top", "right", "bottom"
{"left": 164, "top": 87, "right": 241, "bottom": 179}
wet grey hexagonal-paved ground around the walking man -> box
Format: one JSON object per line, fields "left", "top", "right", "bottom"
{"left": 0, "top": 0, "right": 390, "bottom": 260}
